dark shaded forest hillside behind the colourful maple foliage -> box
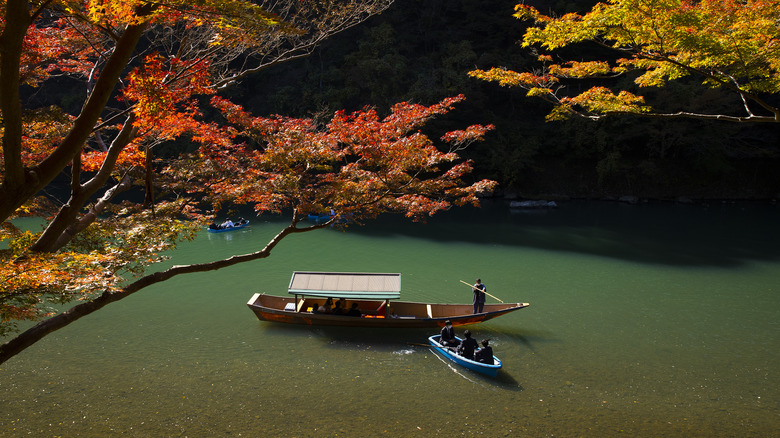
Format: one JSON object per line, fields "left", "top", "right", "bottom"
{"left": 221, "top": 0, "right": 780, "bottom": 199}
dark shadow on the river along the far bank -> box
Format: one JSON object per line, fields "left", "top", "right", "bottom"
{"left": 280, "top": 201, "right": 780, "bottom": 267}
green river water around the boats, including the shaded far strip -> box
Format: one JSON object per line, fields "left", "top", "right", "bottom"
{"left": 0, "top": 202, "right": 780, "bottom": 437}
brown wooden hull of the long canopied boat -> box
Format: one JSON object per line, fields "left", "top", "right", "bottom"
{"left": 247, "top": 294, "right": 528, "bottom": 328}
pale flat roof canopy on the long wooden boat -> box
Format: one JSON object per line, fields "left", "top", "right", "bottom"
{"left": 288, "top": 271, "right": 401, "bottom": 300}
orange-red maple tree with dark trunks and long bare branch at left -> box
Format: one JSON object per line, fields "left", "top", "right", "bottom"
{"left": 0, "top": 0, "right": 494, "bottom": 363}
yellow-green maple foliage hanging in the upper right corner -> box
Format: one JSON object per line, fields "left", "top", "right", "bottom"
{"left": 469, "top": 0, "right": 780, "bottom": 123}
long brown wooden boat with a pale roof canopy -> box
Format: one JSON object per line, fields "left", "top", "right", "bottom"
{"left": 247, "top": 272, "right": 529, "bottom": 328}
